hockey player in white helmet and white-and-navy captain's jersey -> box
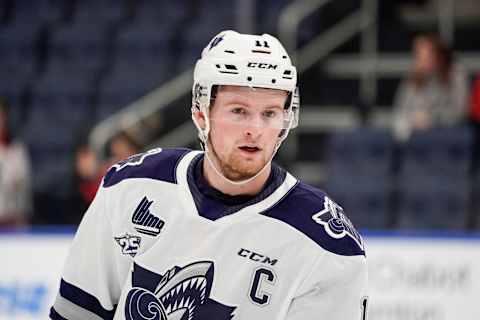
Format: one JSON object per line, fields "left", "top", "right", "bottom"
{"left": 50, "top": 31, "right": 367, "bottom": 320}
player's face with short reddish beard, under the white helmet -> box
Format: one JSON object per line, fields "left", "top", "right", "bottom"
{"left": 208, "top": 86, "right": 287, "bottom": 181}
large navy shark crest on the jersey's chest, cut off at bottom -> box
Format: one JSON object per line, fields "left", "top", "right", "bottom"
{"left": 125, "top": 261, "right": 235, "bottom": 320}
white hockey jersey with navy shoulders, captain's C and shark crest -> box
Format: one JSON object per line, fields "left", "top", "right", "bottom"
{"left": 50, "top": 149, "right": 367, "bottom": 320}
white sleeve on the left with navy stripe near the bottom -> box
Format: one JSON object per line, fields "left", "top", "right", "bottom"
{"left": 50, "top": 182, "right": 124, "bottom": 320}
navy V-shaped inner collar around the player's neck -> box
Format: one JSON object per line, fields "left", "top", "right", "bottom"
{"left": 187, "top": 154, "right": 286, "bottom": 221}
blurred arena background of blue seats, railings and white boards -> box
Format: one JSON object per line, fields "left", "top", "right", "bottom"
{"left": 0, "top": 0, "right": 480, "bottom": 320}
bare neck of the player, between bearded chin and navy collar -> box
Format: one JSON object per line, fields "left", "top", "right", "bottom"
{"left": 203, "top": 154, "right": 272, "bottom": 196}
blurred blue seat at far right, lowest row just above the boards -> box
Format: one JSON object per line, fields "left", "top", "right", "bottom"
{"left": 398, "top": 179, "right": 470, "bottom": 230}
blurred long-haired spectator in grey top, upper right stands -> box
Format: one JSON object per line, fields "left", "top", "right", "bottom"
{"left": 393, "top": 34, "right": 468, "bottom": 141}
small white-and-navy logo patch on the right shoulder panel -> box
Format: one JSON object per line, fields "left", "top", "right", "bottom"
{"left": 312, "top": 197, "right": 364, "bottom": 250}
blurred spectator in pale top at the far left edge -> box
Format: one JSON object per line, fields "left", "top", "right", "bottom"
{"left": 0, "top": 100, "right": 31, "bottom": 227}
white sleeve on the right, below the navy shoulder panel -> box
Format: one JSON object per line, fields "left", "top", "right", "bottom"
{"left": 285, "top": 253, "right": 368, "bottom": 320}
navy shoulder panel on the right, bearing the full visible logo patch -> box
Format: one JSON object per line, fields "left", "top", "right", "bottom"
{"left": 262, "top": 182, "right": 365, "bottom": 256}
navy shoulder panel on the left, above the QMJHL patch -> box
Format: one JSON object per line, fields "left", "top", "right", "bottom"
{"left": 103, "top": 148, "right": 191, "bottom": 188}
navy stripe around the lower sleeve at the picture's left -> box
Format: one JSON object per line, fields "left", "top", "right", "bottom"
{"left": 60, "top": 279, "right": 115, "bottom": 319}
